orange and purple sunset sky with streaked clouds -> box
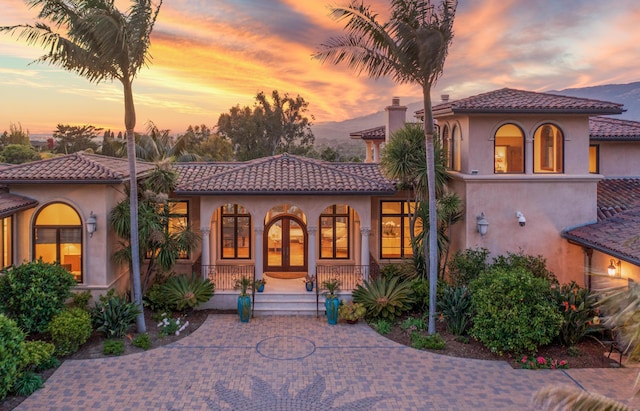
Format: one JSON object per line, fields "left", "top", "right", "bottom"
{"left": 0, "top": 0, "right": 640, "bottom": 135}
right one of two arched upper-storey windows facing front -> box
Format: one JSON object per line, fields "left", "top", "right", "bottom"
{"left": 533, "top": 124, "right": 564, "bottom": 173}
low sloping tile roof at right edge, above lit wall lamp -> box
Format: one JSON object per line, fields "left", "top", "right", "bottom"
{"left": 562, "top": 207, "right": 640, "bottom": 265}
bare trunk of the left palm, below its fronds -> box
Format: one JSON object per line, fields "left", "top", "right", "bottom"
{"left": 123, "top": 82, "right": 147, "bottom": 333}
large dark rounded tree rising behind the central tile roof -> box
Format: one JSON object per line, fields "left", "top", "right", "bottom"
{"left": 218, "top": 90, "right": 315, "bottom": 161}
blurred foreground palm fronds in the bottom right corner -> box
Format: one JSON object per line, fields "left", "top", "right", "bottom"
{"left": 534, "top": 282, "right": 640, "bottom": 411}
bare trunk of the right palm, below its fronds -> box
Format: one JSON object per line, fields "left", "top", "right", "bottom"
{"left": 422, "top": 83, "right": 438, "bottom": 334}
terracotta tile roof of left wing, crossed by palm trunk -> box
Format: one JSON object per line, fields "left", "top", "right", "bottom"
{"left": 0, "top": 152, "right": 154, "bottom": 184}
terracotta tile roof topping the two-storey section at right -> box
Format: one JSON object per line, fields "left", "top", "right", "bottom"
{"left": 433, "top": 88, "right": 624, "bottom": 117}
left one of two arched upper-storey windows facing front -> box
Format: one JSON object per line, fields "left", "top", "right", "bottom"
{"left": 493, "top": 124, "right": 524, "bottom": 173}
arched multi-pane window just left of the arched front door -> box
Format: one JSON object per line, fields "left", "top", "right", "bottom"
{"left": 220, "top": 204, "right": 251, "bottom": 259}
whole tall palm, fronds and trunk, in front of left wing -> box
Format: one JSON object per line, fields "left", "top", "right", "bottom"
{"left": 0, "top": 0, "right": 162, "bottom": 333}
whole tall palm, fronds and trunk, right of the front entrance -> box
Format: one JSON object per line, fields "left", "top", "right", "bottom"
{"left": 314, "top": 0, "right": 458, "bottom": 334}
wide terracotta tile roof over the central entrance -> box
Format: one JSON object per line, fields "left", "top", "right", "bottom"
{"left": 175, "top": 154, "right": 396, "bottom": 195}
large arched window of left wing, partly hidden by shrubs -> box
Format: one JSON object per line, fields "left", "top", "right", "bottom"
{"left": 33, "top": 203, "right": 83, "bottom": 283}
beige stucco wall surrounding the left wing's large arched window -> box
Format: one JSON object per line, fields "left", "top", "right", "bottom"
{"left": 11, "top": 184, "right": 128, "bottom": 294}
